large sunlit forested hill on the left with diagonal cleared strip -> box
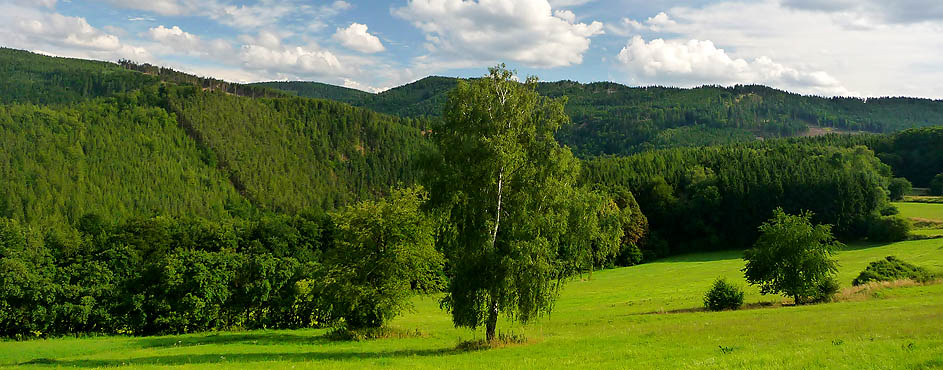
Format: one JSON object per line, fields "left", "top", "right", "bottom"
{"left": 0, "top": 49, "right": 426, "bottom": 225}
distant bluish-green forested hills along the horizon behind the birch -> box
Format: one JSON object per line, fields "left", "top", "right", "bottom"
{"left": 254, "top": 77, "right": 943, "bottom": 157}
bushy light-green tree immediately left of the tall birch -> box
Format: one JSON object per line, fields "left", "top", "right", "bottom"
{"left": 323, "top": 188, "right": 444, "bottom": 329}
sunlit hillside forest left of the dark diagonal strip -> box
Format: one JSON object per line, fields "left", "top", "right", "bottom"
{"left": 0, "top": 98, "right": 240, "bottom": 226}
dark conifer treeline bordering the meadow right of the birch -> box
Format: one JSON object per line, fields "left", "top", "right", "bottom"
{"left": 583, "top": 142, "right": 894, "bottom": 258}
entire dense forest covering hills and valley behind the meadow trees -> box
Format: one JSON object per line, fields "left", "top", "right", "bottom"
{"left": 0, "top": 49, "right": 943, "bottom": 337}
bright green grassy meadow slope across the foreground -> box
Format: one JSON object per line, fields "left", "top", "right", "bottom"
{"left": 0, "top": 240, "right": 943, "bottom": 369}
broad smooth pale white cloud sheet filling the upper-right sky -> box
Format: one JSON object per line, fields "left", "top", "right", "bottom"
{"left": 632, "top": 0, "right": 943, "bottom": 98}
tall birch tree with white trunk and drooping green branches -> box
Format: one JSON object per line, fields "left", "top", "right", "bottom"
{"left": 427, "top": 65, "right": 600, "bottom": 341}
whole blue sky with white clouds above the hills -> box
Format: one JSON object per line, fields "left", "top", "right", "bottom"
{"left": 0, "top": 0, "right": 943, "bottom": 98}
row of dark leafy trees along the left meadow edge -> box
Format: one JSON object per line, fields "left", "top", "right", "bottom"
{"left": 0, "top": 214, "right": 334, "bottom": 338}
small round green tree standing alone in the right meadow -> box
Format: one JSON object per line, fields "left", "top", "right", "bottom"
{"left": 743, "top": 208, "right": 841, "bottom": 304}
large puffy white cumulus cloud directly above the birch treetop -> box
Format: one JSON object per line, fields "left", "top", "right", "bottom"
{"left": 393, "top": 0, "right": 603, "bottom": 68}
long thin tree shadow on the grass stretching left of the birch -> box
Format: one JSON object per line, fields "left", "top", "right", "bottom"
{"left": 14, "top": 347, "right": 465, "bottom": 368}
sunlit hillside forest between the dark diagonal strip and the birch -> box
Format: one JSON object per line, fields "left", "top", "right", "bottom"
{"left": 168, "top": 88, "right": 426, "bottom": 213}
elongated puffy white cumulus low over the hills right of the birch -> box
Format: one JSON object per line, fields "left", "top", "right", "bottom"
{"left": 618, "top": 36, "right": 848, "bottom": 95}
